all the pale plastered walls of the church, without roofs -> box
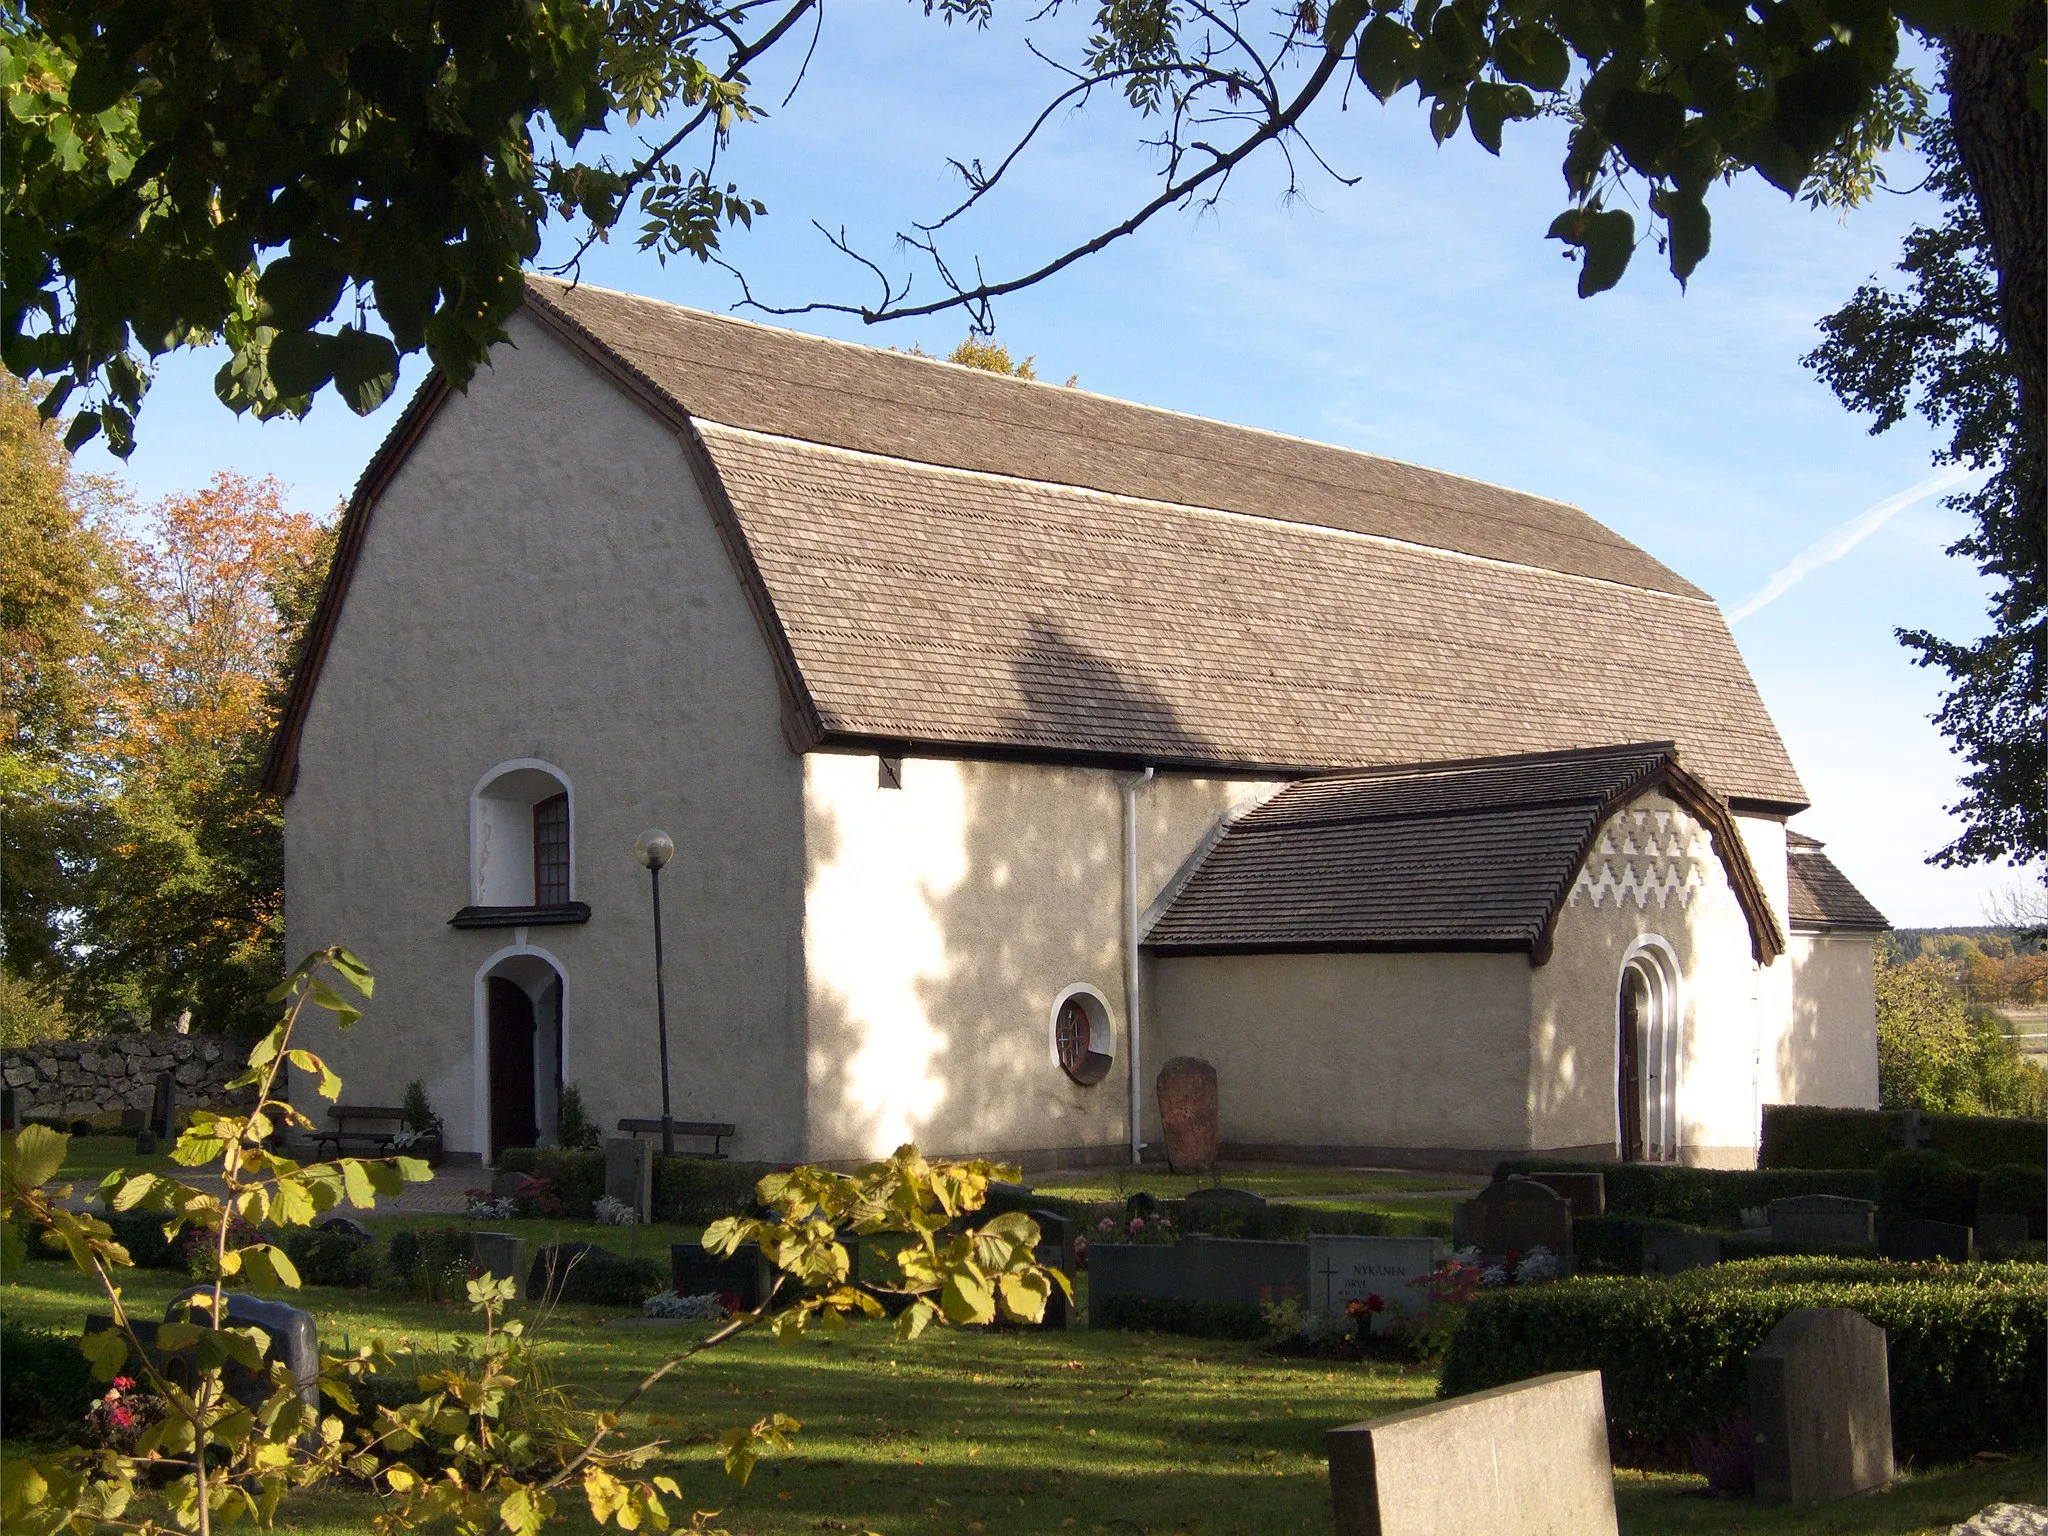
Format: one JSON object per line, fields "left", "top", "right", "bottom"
{"left": 285, "top": 319, "right": 1876, "bottom": 1165}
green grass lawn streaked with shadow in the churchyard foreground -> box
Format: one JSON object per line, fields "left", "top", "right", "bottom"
{"left": 0, "top": 1253, "right": 2042, "bottom": 1536}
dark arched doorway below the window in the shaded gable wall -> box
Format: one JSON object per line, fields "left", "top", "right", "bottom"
{"left": 477, "top": 950, "right": 565, "bottom": 1163}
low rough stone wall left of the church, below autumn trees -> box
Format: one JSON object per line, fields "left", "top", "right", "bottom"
{"left": 0, "top": 1034, "right": 244, "bottom": 1120}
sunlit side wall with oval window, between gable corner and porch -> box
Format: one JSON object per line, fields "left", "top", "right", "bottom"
{"left": 803, "top": 752, "right": 1266, "bottom": 1161}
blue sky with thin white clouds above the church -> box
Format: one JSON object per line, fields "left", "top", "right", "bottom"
{"left": 72, "top": 0, "right": 2013, "bottom": 924}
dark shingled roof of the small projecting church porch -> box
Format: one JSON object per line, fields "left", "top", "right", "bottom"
{"left": 1145, "top": 741, "right": 1784, "bottom": 965}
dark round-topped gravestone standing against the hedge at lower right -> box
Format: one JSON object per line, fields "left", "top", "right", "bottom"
{"left": 1749, "top": 1307, "right": 1892, "bottom": 1503}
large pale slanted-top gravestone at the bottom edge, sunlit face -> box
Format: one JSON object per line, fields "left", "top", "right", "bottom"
{"left": 1323, "top": 1370, "right": 1616, "bottom": 1536}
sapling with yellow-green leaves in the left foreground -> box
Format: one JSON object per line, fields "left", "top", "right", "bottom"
{"left": 0, "top": 948, "right": 1071, "bottom": 1536}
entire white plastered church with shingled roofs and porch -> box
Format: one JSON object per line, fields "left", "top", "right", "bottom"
{"left": 268, "top": 279, "right": 1884, "bottom": 1167}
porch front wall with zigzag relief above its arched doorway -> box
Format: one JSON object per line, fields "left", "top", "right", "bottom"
{"left": 1528, "top": 795, "right": 1788, "bottom": 1167}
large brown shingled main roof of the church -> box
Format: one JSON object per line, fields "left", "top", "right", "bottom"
{"left": 268, "top": 279, "right": 1806, "bottom": 809}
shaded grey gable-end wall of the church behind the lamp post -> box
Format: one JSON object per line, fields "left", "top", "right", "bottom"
{"left": 285, "top": 317, "right": 803, "bottom": 1159}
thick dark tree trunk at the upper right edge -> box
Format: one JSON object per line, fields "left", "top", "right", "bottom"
{"left": 1944, "top": 10, "right": 2048, "bottom": 552}
